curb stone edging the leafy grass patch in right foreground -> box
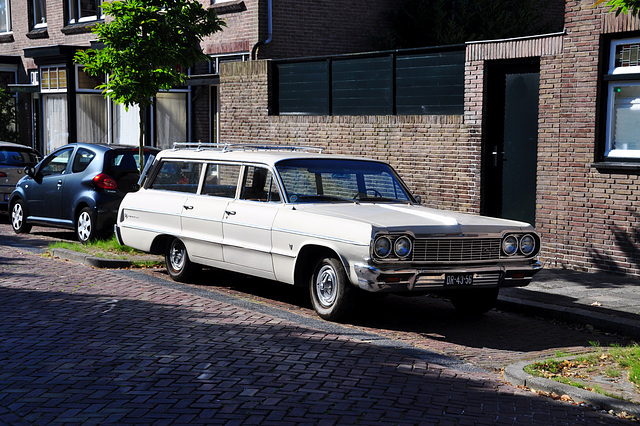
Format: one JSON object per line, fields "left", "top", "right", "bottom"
{"left": 504, "top": 360, "right": 640, "bottom": 417}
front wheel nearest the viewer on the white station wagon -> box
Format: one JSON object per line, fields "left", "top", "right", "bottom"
{"left": 309, "top": 257, "right": 354, "bottom": 321}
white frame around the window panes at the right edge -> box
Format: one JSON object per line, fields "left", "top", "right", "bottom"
{"left": 604, "top": 38, "right": 640, "bottom": 159}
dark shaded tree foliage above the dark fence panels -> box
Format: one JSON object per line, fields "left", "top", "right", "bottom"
{"left": 374, "top": 0, "right": 556, "bottom": 50}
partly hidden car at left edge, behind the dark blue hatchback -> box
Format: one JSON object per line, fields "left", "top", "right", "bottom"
{"left": 0, "top": 141, "right": 41, "bottom": 212}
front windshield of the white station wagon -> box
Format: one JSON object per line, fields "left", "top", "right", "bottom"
{"left": 276, "top": 158, "right": 413, "bottom": 203}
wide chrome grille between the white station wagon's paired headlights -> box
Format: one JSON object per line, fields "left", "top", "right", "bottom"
{"left": 413, "top": 238, "right": 501, "bottom": 263}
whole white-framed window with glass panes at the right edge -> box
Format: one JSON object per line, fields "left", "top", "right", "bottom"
{"left": 605, "top": 38, "right": 640, "bottom": 159}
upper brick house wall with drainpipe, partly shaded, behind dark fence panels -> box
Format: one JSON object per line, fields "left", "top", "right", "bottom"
{"left": 204, "top": 0, "right": 397, "bottom": 59}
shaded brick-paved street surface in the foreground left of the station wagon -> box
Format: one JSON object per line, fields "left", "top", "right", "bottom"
{"left": 0, "top": 246, "right": 632, "bottom": 425}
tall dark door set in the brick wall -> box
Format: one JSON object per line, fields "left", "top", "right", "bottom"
{"left": 482, "top": 61, "right": 540, "bottom": 225}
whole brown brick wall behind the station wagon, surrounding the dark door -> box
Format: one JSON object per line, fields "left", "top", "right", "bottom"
{"left": 220, "top": 1, "right": 640, "bottom": 276}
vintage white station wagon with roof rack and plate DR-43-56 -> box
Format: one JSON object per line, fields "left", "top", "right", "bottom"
{"left": 116, "top": 144, "right": 541, "bottom": 320}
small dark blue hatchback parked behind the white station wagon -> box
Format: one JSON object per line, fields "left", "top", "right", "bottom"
{"left": 9, "top": 143, "right": 159, "bottom": 243}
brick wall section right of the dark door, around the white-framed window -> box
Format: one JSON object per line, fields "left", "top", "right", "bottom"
{"left": 541, "top": 0, "right": 640, "bottom": 276}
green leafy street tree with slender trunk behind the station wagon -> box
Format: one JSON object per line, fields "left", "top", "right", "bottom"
{"left": 74, "top": 0, "right": 225, "bottom": 169}
